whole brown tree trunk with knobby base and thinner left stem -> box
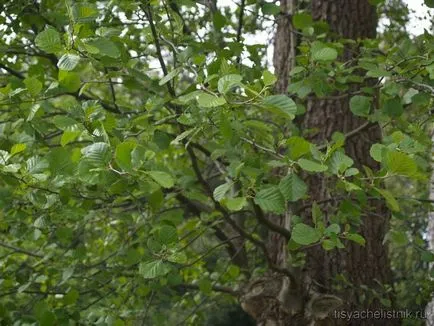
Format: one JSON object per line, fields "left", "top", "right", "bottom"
{"left": 242, "top": 0, "right": 398, "bottom": 326}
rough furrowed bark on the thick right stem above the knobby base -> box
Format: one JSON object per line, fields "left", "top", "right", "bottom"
{"left": 301, "top": 0, "right": 397, "bottom": 325}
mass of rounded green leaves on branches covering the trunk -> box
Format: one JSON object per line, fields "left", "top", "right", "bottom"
{"left": 0, "top": 0, "right": 434, "bottom": 325}
